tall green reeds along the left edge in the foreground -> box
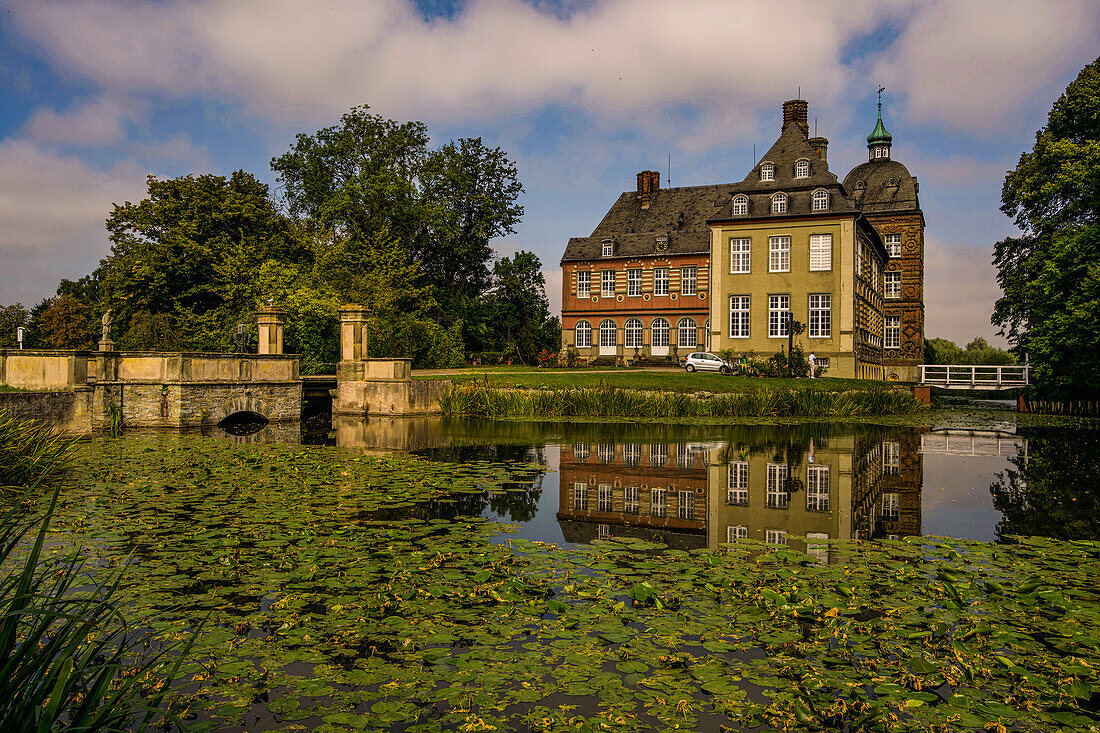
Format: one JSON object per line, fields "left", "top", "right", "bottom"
{"left": 0, "top": 412, "right": 178, "bottom": 731}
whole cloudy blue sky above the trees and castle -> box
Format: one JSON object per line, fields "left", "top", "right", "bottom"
{"left": 0, "top": 0, "right": 1100, "bottom": 342}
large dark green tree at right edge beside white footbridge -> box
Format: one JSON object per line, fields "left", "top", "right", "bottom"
{"left": 993, "top": 58, "right": 1100, "bottom": 398}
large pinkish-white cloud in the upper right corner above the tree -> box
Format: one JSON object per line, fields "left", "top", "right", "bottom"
{"left": 873, "top": 0, "right": 1100, "bottom": 130}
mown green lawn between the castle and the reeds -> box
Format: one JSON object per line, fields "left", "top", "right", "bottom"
{"left": 422, "top": 367, "right": 887, "bottom": 393}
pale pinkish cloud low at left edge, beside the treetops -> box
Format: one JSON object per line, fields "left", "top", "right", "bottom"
{"left": 0, "top": 140, "right": 145, "bottom": 304}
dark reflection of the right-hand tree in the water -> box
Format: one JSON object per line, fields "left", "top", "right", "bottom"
{"left": 989, "top": 428, "right": 1100, "bottom": 540}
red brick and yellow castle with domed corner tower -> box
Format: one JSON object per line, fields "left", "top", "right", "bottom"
{"left": 561, "top": 99, "right": 924, "bottom": 380}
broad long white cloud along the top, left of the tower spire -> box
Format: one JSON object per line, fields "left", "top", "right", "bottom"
{"left": 6, "top": 0, "right": 895, "bottom": 127}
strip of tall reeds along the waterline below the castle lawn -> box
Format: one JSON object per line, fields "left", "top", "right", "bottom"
{"left": 440, "top": 382, "right": 924, "bottom": 419}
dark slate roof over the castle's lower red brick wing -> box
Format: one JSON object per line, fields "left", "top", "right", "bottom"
{"left": 561, "top": 184, "right": 734, "bottom": 262}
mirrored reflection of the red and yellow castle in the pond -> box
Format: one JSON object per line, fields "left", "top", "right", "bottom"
{"left": 558, "top": 431, "right": 922, "bottom": 561}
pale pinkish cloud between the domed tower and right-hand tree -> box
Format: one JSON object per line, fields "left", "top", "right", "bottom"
{"left": 924, "top": 234, "right": 1007, "bottom": 347}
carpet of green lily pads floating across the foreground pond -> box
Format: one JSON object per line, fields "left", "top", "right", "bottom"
{"left": 21, "top": 438, "right": 1100, "bottom": 732}
